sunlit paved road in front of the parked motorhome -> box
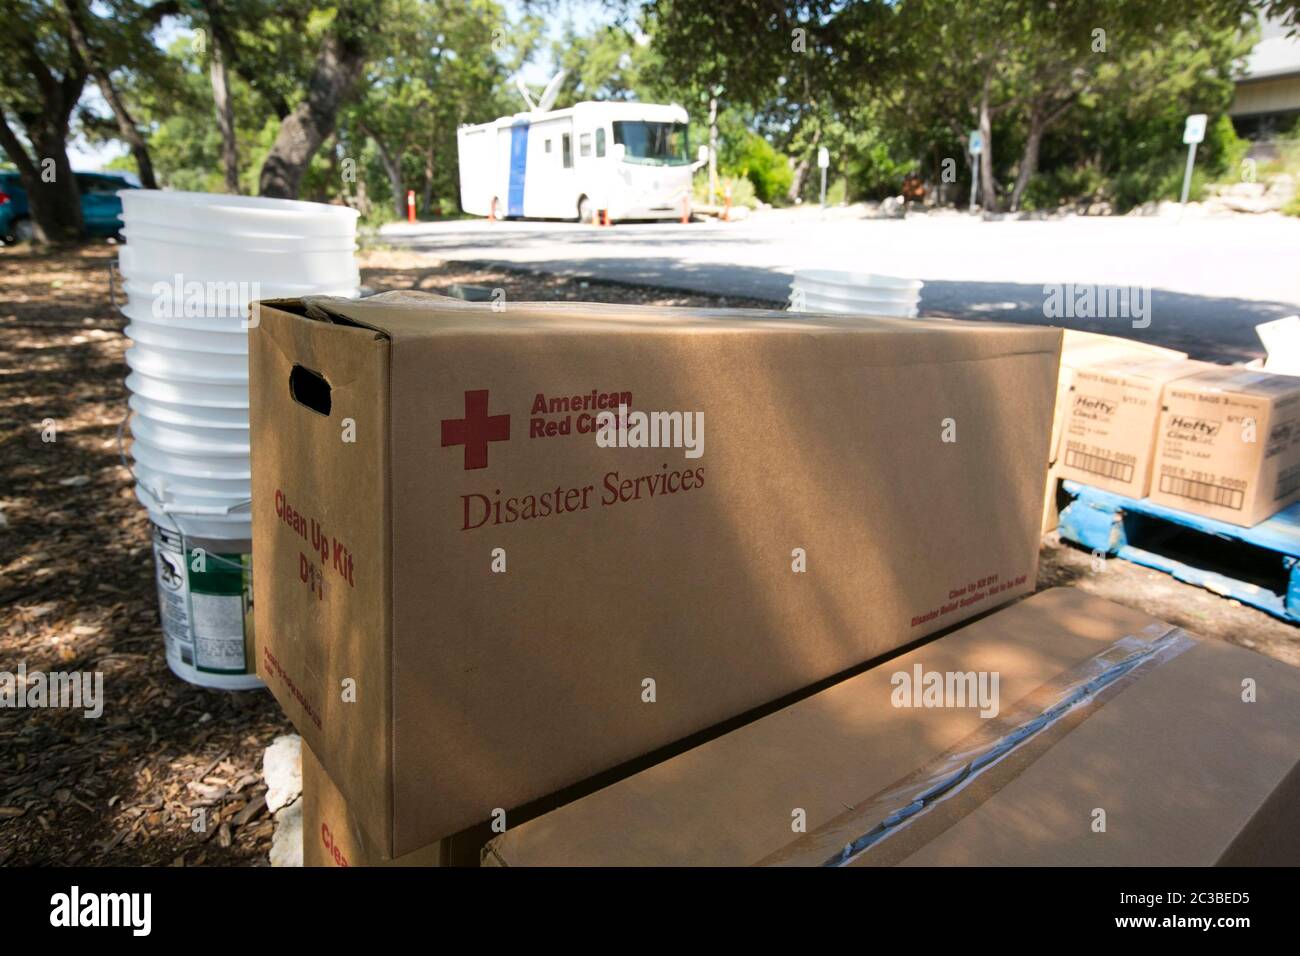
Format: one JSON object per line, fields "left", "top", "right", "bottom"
{"left": 384, "top": 209, "right": 1300, "bottom": 362}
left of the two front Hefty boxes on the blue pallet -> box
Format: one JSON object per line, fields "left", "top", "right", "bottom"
{"left": 1058, "top": 358, "right": 1214, "bottom": 498}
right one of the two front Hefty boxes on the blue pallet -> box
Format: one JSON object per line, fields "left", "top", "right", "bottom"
{"left": 1151, "top": 367, "right": 1300, "bottom": 527}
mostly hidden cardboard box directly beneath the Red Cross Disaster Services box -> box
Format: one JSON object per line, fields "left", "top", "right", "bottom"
{"left": 303, "top": 744, "right": 451, "bottom": 866}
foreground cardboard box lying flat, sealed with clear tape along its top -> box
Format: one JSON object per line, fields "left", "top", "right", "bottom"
{"left": 484, "top": 588, "right": 1300, "bottom": 866}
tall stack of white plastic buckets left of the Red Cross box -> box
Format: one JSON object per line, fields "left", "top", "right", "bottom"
{"left": 118, "top": 190, "right": 360, "bottom": 689}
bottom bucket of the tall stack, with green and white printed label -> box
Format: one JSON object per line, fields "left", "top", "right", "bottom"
{"left": 150, "top": 520, "right": 264, "bottom": 691}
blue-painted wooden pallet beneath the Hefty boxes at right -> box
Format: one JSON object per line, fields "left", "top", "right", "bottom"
{"left": 1060, "top": 480, "right": 1300, "bottom": 623}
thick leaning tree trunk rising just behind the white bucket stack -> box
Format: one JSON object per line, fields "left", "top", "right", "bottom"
{"left": 257, "top": 27, "right": 365, "bottom": 199}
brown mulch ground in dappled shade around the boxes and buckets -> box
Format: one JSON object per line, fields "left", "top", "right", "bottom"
{"left": 0, "top": 238, "right": 1300, "bottom": 866}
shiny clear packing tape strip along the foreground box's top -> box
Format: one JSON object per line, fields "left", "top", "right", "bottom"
{"left": 758, "top": 624, "right": 1196, "bottom": 866}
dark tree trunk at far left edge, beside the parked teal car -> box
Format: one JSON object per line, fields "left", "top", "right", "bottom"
{"left": 0, "top": 0, "right": 90, "bottom": 242}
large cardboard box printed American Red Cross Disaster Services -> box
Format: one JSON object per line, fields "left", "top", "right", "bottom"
{"left": 250, "top": 294, "right": 1061, "bottom": 857}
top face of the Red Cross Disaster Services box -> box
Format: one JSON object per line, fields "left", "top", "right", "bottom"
{"left": 289, "top": 291, "right": 1061, "bottom": 365}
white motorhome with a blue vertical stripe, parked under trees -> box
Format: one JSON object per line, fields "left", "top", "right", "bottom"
{"left": 456, "top": 96, "right": 707, "bottom": 221}
